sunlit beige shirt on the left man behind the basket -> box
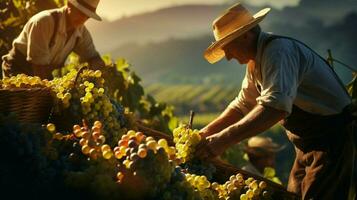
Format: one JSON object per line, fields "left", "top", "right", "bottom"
{"left": 13, "top": 7, "right": 99, "bottom": 66}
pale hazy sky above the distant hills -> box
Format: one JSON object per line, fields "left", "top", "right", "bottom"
{"left": 98, "top": 0, "right": 300, "bottom": 21}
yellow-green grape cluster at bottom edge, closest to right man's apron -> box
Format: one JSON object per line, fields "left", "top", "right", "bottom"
{"left": 211, "top": 173, "right": 270, "bottom": 200}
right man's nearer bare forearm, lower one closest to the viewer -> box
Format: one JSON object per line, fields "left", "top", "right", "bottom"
{"left": 218, "top": 105, "right": 287, "bottom": 145}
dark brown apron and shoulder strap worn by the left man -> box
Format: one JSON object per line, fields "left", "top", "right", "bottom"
{"left": 1, "top": 11, "right": 60, "bottom": 77}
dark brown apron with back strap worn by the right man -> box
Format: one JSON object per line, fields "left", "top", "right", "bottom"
{"left": 263, "top": 36, "right": 354, "bottom": 200}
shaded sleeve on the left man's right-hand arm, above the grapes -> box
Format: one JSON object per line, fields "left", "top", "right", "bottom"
{"left": 73, "top": 26, "right": 99, "bottom": 62}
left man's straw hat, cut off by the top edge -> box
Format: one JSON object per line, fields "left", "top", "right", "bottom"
{"left": 68, "top": 0, "right": 102, "bottom": 21}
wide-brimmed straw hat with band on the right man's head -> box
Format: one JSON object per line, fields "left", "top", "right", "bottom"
{"left": 204, "top": 3, "right": 270, "bottom": 64}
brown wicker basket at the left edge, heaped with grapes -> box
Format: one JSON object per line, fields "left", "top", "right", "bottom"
{"left": 0, "top": 88, "right": 53, "bottom": 123}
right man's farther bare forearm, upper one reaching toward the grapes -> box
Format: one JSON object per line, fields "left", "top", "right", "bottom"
{"left": 201, "top": 107, "right": 243, "bottom": 137}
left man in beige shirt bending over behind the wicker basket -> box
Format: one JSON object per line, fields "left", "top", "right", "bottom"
{"left": 2, "top": 0, "right": 104, "bottom": 79}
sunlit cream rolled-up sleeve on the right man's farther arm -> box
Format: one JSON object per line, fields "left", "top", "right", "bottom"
{"left": 228, "top": 67, "right": 259, "bottom": 115}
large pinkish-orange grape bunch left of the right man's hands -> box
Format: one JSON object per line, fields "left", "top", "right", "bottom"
{"left": 114, "top": 130, "right": 176, "bottom": 187}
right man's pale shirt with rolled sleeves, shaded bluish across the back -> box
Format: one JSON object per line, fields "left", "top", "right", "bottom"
{"left": 229, "top": 32, "right": 351, "bottom": 115}
